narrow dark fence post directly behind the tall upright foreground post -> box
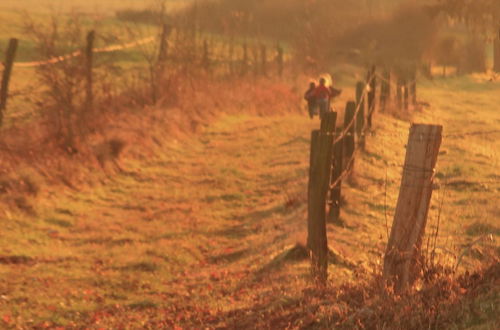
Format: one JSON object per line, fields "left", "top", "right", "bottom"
{"left": 328, "top": 128, "right": 344, "bottom": 223}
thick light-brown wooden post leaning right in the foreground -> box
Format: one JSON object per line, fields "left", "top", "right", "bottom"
{"left": 384, "top": 124, "right": 443, "bottom": 292}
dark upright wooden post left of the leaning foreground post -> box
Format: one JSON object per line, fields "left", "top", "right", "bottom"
{"left": 307, "top": 113, "right": 337, "bottom": 283}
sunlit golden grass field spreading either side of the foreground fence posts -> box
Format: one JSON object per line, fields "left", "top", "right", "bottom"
{"left": 0, "top": 70, "right": 500, "bottom": 329}
